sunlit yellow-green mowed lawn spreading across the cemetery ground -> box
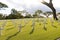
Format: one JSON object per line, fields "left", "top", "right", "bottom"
{"left": 0, "top": 18, "right": 60, "bottom": 40}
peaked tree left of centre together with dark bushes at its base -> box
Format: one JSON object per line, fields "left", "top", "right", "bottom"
{"left": 6, "top": 9, "right": 23, "bottom": 19}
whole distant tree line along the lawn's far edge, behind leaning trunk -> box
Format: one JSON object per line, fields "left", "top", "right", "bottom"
{"left": 0, "top": 9, "right": 60, "bottom": 19}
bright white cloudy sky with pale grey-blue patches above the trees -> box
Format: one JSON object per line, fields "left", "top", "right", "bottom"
{"left": 0, "top": 0, "right": 60, "bottom": 15}
